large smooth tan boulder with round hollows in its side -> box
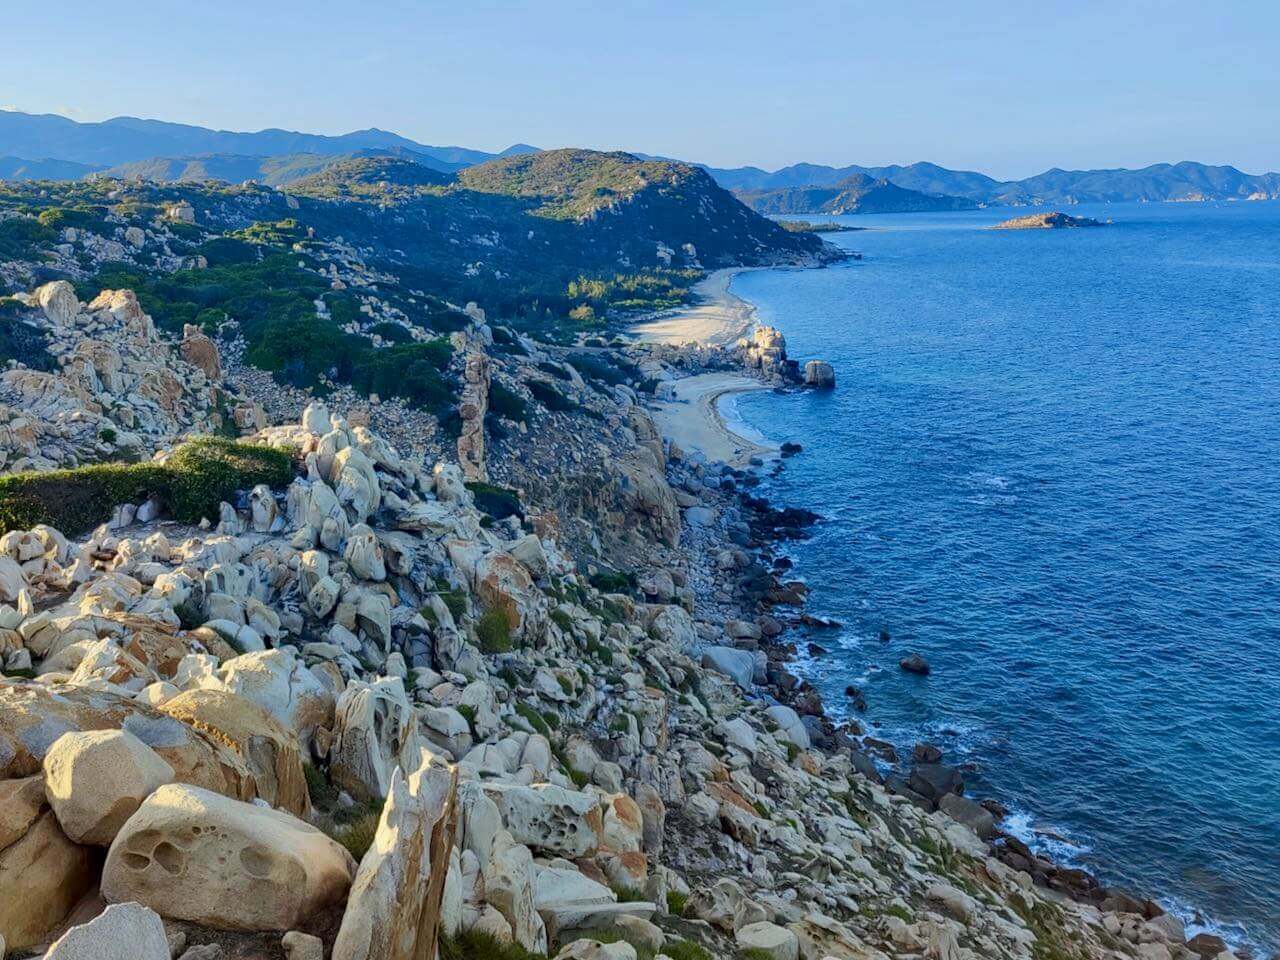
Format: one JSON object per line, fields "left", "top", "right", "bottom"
{"left": 102, "top": 783, "right": 356, "bottom": 931}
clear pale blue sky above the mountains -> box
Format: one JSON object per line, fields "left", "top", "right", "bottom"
{"left": 0, "top": 0, "right": 1280, "bottom": 178}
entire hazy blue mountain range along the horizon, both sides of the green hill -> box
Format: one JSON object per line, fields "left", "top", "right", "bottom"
{"left": 0, "top": 110, "right": 1280, "bottom": 207}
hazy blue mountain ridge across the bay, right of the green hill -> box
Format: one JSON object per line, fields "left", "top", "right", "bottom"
{"left": 707, "top": 163, "right": 1280, "bottom": 204}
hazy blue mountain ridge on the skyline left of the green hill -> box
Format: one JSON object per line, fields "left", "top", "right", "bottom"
{"left": 0, "top": 110, "right": 532, "bottom": 170}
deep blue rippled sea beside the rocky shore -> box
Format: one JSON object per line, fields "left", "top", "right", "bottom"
{"left": 733, "top": 202, "right": 1280, "bottom": 950}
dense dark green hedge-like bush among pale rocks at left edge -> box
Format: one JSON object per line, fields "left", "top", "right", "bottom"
{"left": 0, "top": 436, "right": 293, "bottom": 535}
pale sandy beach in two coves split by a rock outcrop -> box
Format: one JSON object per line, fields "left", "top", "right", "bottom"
{"left": 631, "top": 269, "right": 778, "bottom": 466}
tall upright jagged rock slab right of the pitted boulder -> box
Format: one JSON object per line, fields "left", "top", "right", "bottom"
{"left": 333, "top": 760, "right": 457, "bottom": 960}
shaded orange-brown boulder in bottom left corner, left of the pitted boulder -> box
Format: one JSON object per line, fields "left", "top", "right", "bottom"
{"left": 0, "top": 810, "right": 102, "bottom": 950}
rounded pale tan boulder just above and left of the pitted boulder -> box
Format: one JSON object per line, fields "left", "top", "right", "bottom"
{"left": 45, "top": 730, "right": 174, "bottom": 846}
